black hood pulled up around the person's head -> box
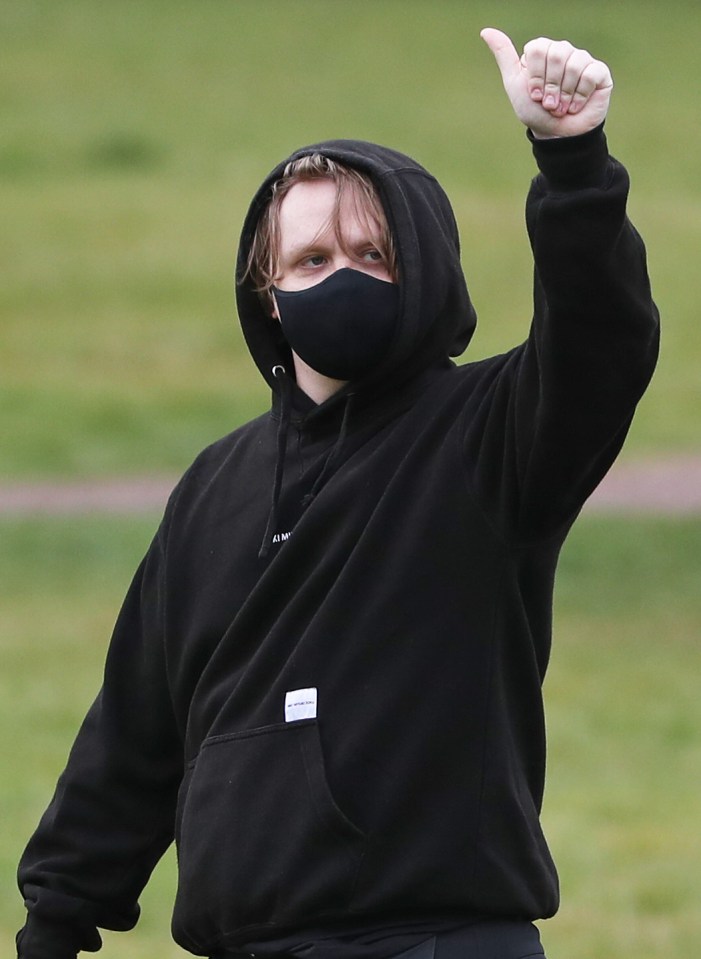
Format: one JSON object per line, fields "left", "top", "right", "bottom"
{"left": 236, "top": 140, "right": 476, "bottom": 398}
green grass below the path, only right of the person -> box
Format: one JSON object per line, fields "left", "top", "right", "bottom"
{"left": 544, "top": 518, "right": 701, "bottom": 959}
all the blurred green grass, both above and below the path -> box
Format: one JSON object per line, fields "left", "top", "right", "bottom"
{"left": 0, "top": 0, "right": 701, "bottom": 959}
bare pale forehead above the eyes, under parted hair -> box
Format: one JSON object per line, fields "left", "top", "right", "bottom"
{"left": 279, "top": 179, "right": 380, "bottom": 249}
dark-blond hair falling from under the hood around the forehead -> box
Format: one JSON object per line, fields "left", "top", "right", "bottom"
{"left": 243, "top": 153, "right": 397, "bottom": 296}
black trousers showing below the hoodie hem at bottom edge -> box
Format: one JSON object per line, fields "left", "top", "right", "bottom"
{"left": 395, "top": 922, "right": 545, "bottom": 959}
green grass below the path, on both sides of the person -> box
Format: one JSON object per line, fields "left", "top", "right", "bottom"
{"left": 0, "top": 516, "right": 701, "bottom": 959}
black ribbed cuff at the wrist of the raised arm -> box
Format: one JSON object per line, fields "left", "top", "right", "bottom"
{"left": 528, "top": 123, "right": 610, "bottom": 190}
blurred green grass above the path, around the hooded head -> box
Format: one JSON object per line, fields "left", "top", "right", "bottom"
{"left": 0, "top": 0, "right": 701, "bottom": 478}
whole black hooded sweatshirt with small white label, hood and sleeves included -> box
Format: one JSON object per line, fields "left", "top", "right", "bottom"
{"left": 19, "top": 128, "right": 657, "bottom": 959}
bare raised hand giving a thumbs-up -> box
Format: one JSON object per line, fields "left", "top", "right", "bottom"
{"left": 480, "top": 27, "right": 613, "bottom": 139}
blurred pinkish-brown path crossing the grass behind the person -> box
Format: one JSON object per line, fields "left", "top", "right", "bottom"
{"left": 0, "top": 454, "right": 701, "bottom": 516}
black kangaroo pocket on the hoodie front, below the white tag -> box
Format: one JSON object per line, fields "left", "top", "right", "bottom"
{"left": 174, "top": 719, "right": 364, "bottom": 945}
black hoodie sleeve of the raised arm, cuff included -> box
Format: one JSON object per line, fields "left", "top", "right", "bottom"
{"left": 464, "top": 127, "right": 658, "bottom": 541}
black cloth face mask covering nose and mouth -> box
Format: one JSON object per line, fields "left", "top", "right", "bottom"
{"left": 273, "top": 268, "right": 399, "bottom": 380}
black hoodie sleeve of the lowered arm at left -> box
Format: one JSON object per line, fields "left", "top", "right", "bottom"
{"left": 17, "top": 520, "right": 182, "bottom": 959}
